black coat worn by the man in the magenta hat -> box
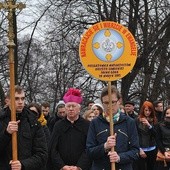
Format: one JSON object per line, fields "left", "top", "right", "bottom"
{"left": 48, "top": 117, "right": 91, "bottom": 170}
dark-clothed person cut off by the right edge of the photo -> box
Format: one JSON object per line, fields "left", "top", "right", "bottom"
{"left": 156, "top": 106, "right": 170, "bottom": 170}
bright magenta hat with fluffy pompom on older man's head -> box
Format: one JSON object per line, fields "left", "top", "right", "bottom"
{"left": 63, "top": 88, "right": 83, "bottom": 104}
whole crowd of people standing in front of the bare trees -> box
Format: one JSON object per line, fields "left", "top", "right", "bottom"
{"left": 0, "top": 85, "right": 170, "bottom": 170}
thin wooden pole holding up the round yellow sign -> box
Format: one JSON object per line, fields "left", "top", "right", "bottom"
{"left": 108, "top": 81, "right": 115, "bottom": 170}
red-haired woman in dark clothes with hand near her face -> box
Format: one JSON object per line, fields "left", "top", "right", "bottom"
{"left": 136, "top": 101, "right": 157, "bottom": 170}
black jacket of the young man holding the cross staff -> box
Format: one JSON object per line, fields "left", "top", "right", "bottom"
{"left": 0, "top": 108, "right": 48, "bottom": 170}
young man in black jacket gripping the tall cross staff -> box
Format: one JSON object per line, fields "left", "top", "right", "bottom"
{"left": 0, "top": 86, "right": 48, "bottom": 170}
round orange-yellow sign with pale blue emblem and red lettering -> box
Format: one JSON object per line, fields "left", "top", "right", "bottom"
{"left": 79, "top": 21, "right": 137, "bottom": 81}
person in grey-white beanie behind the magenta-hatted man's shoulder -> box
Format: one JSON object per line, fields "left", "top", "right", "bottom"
{"left": 49, "top": 100, "right": 66, "bottom": 133}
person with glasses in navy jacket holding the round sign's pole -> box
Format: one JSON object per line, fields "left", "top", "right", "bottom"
{"left": 86, "top": 86, "right": 139, "bottom": 170}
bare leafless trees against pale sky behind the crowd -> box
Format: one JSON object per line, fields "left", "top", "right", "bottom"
{"left": 0, "top": 0, "right": 170, "bottom": 110}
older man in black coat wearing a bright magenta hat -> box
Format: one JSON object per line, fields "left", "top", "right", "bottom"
{"left": 48, "top": 88, "right": 91, "bottom": 170}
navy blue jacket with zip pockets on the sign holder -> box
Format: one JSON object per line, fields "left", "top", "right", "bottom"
{"left": 86, "top": 113, "right": 139, "bottom": 170}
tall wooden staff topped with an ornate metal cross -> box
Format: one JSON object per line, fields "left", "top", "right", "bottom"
{"left": 0, "top": 0, "right": 25, "bottom": 161}
